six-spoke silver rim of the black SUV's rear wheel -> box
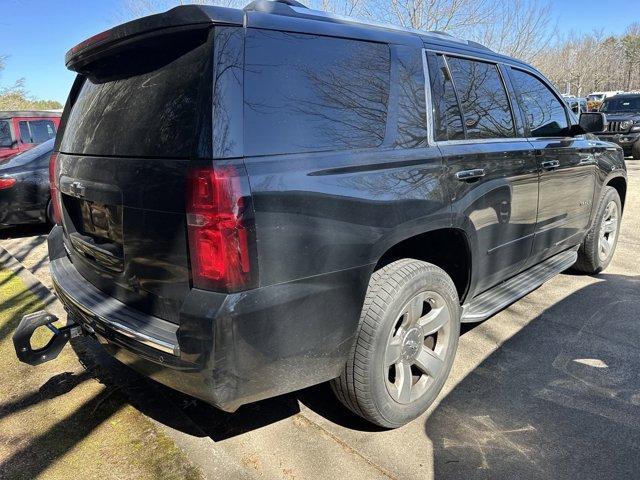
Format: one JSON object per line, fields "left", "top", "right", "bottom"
{"left": 384, "top": 291, "right": 451, "bottom": 404}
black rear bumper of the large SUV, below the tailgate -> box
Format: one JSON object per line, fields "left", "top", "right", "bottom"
{"left": 49, "top": 227, "right": 373, "bottom": 411}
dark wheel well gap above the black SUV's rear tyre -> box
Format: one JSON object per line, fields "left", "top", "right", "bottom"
{"left": 374, "top": 228, "right": 471, "bottom": 302}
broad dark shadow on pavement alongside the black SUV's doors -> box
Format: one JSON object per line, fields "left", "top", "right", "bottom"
{"left": 425, "top": 274, "right": 640, "bottom": 480}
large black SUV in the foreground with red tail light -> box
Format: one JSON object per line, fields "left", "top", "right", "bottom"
{"left": 14, "top": 0, "right": 627, "bottom": 427}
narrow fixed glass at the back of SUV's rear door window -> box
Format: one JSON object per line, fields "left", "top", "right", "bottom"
{"left": 427, "top": 54, "right": 465, "bottom": 141}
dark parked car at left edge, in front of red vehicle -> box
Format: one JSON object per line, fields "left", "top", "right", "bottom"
{"left": 0, "top": 139, "right": 54, "bottom": 227}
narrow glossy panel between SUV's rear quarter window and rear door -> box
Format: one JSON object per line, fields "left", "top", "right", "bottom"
{"left": 396, "top": 47, "right": 428, "bottom": 148}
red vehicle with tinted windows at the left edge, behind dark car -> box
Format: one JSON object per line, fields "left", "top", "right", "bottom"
{"left": 0, "top": 111, "right": 61, "bottom": 163}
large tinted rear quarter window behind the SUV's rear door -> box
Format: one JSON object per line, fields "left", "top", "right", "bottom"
{"left": 244, "top": 30, "right": 390, "bottom": 155}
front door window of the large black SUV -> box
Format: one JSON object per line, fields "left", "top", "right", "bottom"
{"left": 511, "top": 69, "right": 569, "bottom": 137}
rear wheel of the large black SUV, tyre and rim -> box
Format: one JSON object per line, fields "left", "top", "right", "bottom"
{"left": 332, "top": 259, "right": 460, "bottom": 428}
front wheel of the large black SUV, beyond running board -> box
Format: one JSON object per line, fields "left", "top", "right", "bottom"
{"left": 574, "top": 186, "right": 622, "bottom": 274}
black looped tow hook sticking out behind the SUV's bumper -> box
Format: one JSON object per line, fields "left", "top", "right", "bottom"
{"left": 13, "top": 310, "right": 82, "bottom": 365}
